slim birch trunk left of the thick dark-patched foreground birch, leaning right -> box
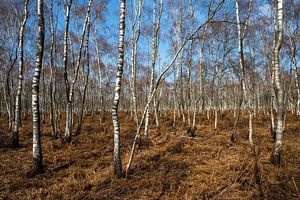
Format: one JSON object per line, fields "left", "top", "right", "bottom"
{"left": 12, "top": 0, "right": 29, "bottom": 148}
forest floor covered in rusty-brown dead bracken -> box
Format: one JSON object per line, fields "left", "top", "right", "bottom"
{"left": 0, "top": 113, "right": 300, "bottom": 200}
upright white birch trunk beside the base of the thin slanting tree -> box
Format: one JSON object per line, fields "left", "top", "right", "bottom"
{"left": 112, "top": 0, "right": 126, "bottom": 177}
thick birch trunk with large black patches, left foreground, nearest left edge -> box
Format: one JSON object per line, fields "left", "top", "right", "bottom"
{"left": 31, "top": 0, "right": 45, "bottom": 175}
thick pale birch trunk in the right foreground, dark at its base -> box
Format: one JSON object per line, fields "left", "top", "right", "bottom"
{"left": 271, "top": 0, "right": 285, "bottom": 164}
